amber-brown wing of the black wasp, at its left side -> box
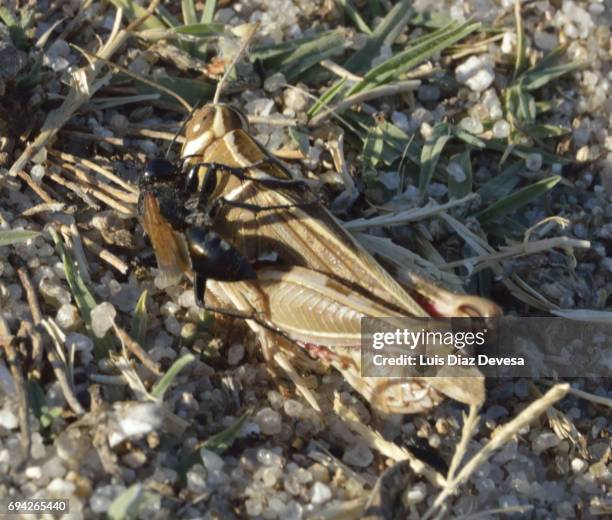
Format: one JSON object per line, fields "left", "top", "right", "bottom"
{"left": 142, "top": 192, "right": 190, "bottom": 285}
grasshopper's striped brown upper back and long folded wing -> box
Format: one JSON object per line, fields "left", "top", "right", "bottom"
{"left": 198, "top": 130, "right": 427, "bottom": 316}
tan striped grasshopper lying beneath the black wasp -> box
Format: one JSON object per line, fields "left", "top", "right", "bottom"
{"left": 151, "top": 104, "right": 499, "bottom": 413}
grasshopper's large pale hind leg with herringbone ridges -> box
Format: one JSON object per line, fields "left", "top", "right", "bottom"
{"left": 211, "top": 267, "right": 485, "bottom": 413}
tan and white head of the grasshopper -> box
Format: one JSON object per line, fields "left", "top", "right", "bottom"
{"left": 181, "top": 103, "right": 249, "bottom": 157}
